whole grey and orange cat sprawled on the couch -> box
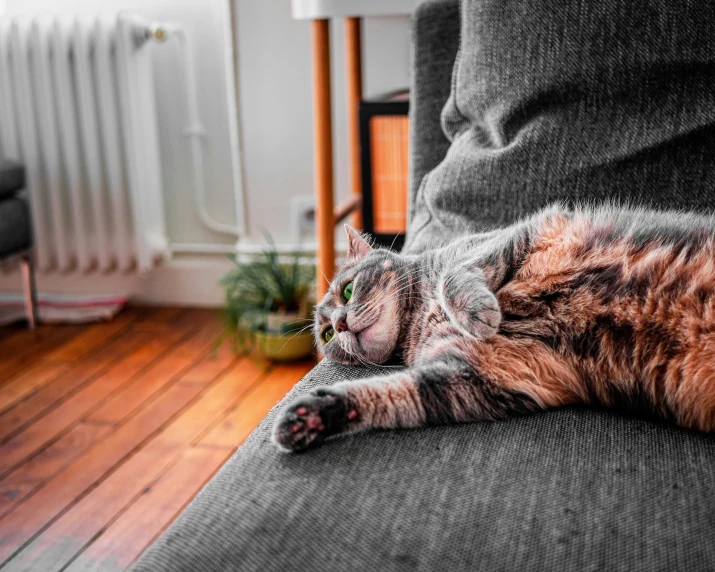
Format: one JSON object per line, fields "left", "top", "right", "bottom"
{"left": 273, "top": 205, "right": 715, "bottom": 451}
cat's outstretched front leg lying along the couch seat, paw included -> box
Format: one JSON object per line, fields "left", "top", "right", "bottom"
{"left": 273, "top": 359, "right": 536, "bottom": 452}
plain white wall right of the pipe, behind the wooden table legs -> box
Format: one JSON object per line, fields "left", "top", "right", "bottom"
{"left": 235, "top": 0, "right": 410, "bottom": 241}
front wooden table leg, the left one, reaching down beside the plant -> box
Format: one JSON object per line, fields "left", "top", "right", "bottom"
{"left": 311, "top": 20, "right": 335, "bottom": 299}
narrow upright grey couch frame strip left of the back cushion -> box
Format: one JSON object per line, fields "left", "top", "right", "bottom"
{"left": 410, "top": 0, "right": 460, "bottom": 226}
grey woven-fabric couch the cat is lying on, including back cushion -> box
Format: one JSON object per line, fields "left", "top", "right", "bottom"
{"left": 134, "top": 0, "right": 715, "bottom": 572}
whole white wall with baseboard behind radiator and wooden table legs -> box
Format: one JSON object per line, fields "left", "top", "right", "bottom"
{"left": 0, "top": 0, "right": 410, "bottom": 305}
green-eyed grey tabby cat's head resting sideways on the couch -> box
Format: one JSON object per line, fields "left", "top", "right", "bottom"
{"left": 313, "top": 225, "right": 411, "bottom": 364}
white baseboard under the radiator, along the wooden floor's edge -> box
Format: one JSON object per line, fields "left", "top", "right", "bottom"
{"left": 0, "top": 255, "right": 232, "bottom": 308}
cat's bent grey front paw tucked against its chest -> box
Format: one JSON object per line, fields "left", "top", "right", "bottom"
{"left": 437, "top": 264, "right": 501, "bottom": 340}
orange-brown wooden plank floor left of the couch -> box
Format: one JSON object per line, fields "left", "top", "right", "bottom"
{"left": 0, "top": 308, "right": 313, "bottom": 572}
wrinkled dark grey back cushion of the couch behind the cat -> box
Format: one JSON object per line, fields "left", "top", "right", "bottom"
{"left": 406, "top": 0, "right": 715, "bottom": 252}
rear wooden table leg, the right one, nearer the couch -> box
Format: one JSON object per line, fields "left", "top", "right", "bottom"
{"left": 345, "top": 18, "right": 362, "bottom": 229}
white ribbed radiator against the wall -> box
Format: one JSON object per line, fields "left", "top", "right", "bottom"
{"left": 0, "top": 16, "right": 168, "bottom": 272}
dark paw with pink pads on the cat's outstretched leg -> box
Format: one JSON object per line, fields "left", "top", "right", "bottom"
{"left": 273, "top": 387, "right": 358, "bottom": 453}
